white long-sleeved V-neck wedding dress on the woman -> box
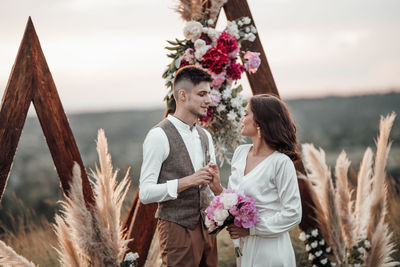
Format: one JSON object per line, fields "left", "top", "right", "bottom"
{"left": 228, "top": 144, "right": 301, "bottom": 267}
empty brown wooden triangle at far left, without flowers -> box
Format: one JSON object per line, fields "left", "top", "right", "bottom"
{"left": 0, "top": 17, "right": 94, "bottom": 205}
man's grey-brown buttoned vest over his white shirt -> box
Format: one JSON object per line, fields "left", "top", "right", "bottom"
{"left": 155, "top": 119, "right": 208, "bottom": 229}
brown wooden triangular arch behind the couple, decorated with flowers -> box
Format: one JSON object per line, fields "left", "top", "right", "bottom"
{"left": 125, "top": 0, "right": 318, "bottom": 266}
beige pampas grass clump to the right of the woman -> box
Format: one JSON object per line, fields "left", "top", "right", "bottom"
{"left": 303, "top": 113, "right": 399, "bottom": 267}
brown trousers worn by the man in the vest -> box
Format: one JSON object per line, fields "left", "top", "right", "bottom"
{"left": 157, "top": 219, "right": 218, "bottom": 267}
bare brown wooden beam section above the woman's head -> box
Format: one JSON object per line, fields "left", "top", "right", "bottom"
{"left": 224, "top": 0, "right": 279, "bottom": 96}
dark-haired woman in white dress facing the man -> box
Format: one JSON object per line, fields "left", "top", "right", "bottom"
{"left": 216, "top": 95, "right": 301, "bottom": 267}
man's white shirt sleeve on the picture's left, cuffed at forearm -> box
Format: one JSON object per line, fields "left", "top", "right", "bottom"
{"left": 139, "top": 127, "right": 178, "bottom": 204}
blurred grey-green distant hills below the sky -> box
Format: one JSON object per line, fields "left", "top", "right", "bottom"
{"left": 0, "top": 93, "right": 400, "bottom": 226}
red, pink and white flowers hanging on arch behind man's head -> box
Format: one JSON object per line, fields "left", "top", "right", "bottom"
{"left": 163, "top": 17, "right": 261, "bottom": 164}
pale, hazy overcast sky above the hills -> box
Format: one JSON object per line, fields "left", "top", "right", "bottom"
{"left": 0, "top": 0, "right": 400, "bottom": 112}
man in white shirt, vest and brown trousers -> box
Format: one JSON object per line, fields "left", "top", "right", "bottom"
{"left": 139, "top": 66, "right": 221, "bottom": 267}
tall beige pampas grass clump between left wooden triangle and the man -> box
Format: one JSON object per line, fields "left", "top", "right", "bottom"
{"left": 54, "top": 130, "right": 130, "bottom": 267}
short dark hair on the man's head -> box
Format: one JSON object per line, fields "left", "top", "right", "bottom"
{"left": 173, "top": 65, "right": 212, "bottom": 97}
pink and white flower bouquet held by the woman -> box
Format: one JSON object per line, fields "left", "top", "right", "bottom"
{"left": 205, "top": 189, "right": 259, "bottom": 257}
